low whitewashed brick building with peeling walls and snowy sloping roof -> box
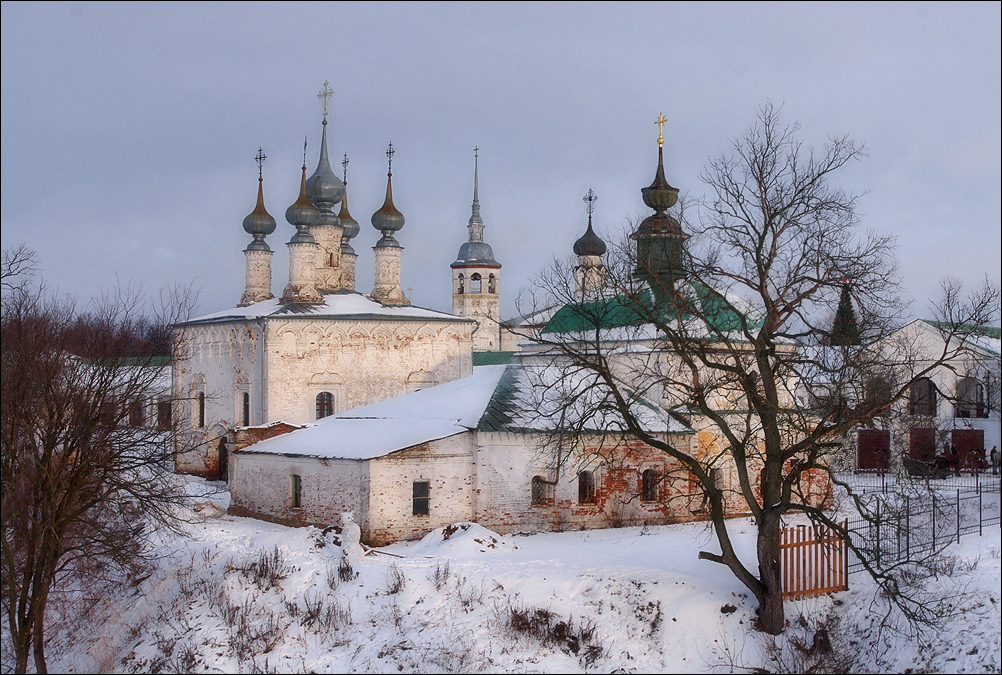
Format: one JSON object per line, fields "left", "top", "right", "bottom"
{"left": 229, "top": 364, "right": 713, "bottom": 545}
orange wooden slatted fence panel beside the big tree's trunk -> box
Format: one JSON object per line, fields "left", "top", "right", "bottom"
{"left": 780, "top": 525, "right": 849, "bottom": 600}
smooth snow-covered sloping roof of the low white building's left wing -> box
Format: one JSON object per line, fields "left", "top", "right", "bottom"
{"left": 230, "top": 366, "right": 506, "bottom": 460}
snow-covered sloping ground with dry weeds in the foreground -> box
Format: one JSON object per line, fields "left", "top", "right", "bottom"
{"left": 23, "top": 480, "right": 1002, "bottom": 673}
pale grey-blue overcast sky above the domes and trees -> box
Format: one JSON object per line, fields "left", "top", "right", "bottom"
{"left": 0, "top": 2, "right": 1002, "bottom": 316}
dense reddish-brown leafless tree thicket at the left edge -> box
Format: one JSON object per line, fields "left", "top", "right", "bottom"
{"left": 0, "top": 251, "right": 199, "bottom": 673}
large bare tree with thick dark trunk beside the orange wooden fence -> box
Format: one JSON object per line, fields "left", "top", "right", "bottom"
{"left": 523, "top": 104, "right": 999, "bottom": 634}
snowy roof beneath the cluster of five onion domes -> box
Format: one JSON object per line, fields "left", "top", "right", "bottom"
{"left": 186, "top": 290, "right": 472, "bottom": 325}
